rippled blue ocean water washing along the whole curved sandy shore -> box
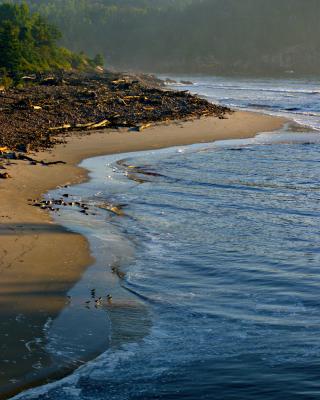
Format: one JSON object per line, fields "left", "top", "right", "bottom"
{"left": 13, "top": 77, "right": 320, "bottom": 400}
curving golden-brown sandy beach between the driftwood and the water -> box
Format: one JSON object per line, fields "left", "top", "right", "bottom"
{"left": 0, "top": 112, "right": 287, "bottom": 397}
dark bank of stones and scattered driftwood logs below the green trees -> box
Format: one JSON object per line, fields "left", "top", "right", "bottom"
{"left": 0, "top": 72, "right": 230, "bottom": 152}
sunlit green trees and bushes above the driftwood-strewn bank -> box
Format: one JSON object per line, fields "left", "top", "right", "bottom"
{"left": 0, "top": 3, "right": 102, "bottom": 78}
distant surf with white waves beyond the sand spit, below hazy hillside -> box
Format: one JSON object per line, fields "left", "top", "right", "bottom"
{"left": 171, "top": 76, "right": 320, "bottom": 129}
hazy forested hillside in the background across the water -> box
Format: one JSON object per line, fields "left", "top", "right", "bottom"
{"left": 4, "top": 0, "right": 320, "bottom": 76}
